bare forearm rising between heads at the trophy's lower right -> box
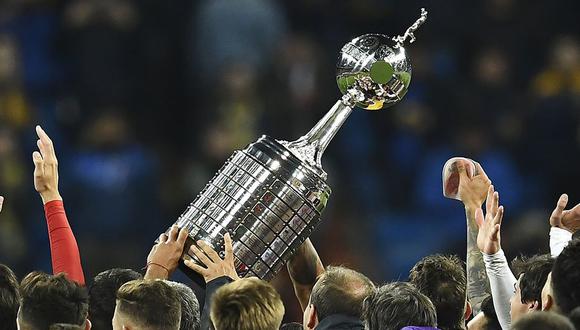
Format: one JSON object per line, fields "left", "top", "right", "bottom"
{"left": 287, "top": 239, "right": 324, "bottom": 311}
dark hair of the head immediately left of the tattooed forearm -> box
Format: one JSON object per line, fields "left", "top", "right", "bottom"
{"left": 409, "top": 254, "right": 467, "bottom": 330}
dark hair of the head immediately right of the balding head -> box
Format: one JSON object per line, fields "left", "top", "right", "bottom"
{"left": 362, "top": 282, "right": 437, "bottom": 330}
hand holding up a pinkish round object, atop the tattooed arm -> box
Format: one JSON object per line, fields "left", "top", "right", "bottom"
{"left": 457, "top": 162, "right": 491, "bottom": 209}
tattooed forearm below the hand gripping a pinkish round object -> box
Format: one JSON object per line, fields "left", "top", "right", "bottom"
{"left": 465, "top": 206, "right": 491, "bottom": 315}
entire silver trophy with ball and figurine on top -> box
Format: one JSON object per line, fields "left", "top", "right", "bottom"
{"left": 170, "top": 9, "right": 427, "bottom": 284}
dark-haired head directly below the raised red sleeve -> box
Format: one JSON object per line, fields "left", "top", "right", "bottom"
{"left": 17, "top": 272, "right": 91, "bottom": 330}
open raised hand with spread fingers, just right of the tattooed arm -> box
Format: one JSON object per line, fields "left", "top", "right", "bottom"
{"left": 475, "top": 186, "right": 504, "bottom": 254}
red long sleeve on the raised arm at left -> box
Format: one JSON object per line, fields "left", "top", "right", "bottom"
{"left": 44, "top": 200, "right": 85, "bottom": 285}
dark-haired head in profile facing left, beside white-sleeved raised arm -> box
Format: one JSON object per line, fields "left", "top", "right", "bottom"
{"left": 510, "top": 254, "right": 554, "bottom": 322}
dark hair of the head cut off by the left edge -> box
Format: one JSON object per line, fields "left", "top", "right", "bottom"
{"left": 0, "top": 264, "right": 20, "bottom": 330}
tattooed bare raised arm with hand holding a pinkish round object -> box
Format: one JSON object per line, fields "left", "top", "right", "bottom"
{"left": 457, "top": 162, "right": 491, "bottom": 315}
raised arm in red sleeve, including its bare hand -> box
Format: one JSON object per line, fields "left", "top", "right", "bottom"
{"left": 32, "top": 126, "right": 85, "bottom": 285}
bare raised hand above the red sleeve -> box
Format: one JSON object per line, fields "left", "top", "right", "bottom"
{"left": 32, "top": 126, "right": 62, "bottom": 204}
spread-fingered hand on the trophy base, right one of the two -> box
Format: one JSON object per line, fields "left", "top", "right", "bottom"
{"left": 185, "top": 233, "right": 239, "bottom": 283}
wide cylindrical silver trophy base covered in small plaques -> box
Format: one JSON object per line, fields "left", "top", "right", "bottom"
{"left": 176, "top": 136, "right": 331, "bottom": 285}
